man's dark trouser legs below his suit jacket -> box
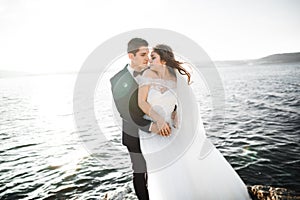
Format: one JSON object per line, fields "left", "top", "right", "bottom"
{"left": 127, "top": 146, "right": 149, "bottom": 200}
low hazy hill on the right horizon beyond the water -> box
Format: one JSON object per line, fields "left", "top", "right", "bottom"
{"left": 214, "top": 52, "right": 300, "bottom": 66}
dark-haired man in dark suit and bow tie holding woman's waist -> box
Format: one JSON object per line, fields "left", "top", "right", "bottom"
{"left": 110, "top": 38, "right": 171, "bottom": 200}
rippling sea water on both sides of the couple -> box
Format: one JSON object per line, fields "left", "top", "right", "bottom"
{"left": 0, "top": 65, "right": 300, "bottom": 199}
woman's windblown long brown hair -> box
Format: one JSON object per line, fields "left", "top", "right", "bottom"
{"left": 153, "top": 44, "right": 191, "bottom": 83}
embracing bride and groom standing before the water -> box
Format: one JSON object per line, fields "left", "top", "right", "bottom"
{"left": 110, "top": 38, "right": 250, "bottom": 200}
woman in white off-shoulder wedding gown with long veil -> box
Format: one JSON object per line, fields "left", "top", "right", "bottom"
{"left": 138, "top": 45, "right": 250, "bottom": 200}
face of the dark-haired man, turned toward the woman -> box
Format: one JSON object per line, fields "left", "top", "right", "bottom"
{"left": 129, "top": 46, "right": 149, "bottom": 70}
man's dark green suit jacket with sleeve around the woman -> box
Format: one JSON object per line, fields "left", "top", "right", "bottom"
{"left": 110, "top": 65, "right": 151, "bottom": 147}
